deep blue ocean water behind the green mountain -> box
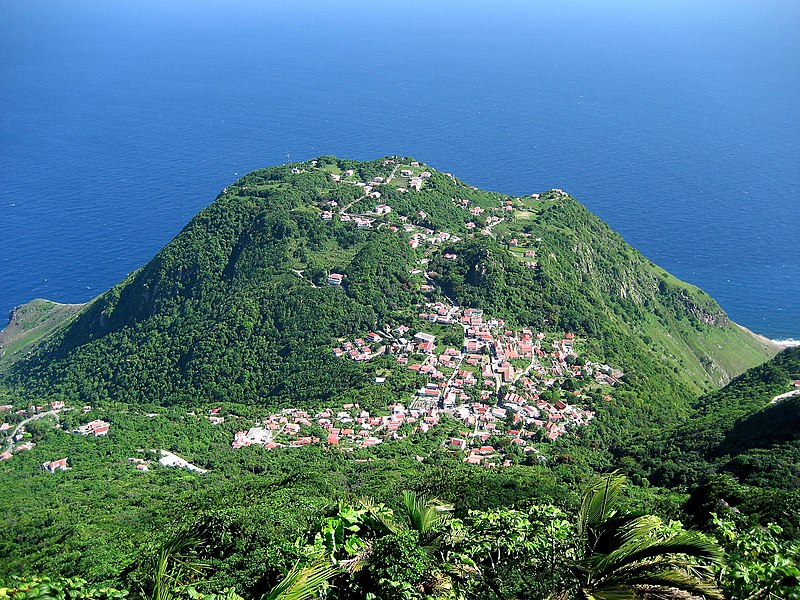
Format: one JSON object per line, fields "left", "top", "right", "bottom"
{"left": 0, "top": 0, "right": 800, "bottom": 338}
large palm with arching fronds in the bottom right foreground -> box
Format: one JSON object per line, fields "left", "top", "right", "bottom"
{"left": 553, "top": 472, "right": 723, "bottom": 600}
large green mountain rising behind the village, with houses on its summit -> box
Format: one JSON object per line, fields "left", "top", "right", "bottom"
{"left": 3, "top": 157, "right": 776, "bottom": 442}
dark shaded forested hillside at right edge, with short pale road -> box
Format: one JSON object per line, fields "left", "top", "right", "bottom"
{"left": 620, "top": 348, "right": 800, "bottom": 535}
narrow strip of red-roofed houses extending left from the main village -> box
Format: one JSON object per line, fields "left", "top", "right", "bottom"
{"left": 231, "top": 403, "right": 439, "bottom": 451}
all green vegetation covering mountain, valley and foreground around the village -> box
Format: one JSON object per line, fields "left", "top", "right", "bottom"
{"left": 0, "top": 157, "right": 800, "bottom": 600}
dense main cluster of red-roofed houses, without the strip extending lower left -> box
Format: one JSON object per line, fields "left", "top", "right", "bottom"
{"left": 324, "top": 301, "right": 621, "bottom": 466}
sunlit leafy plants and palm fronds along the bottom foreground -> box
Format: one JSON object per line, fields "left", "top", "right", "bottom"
{"left": 0, "top": 473, "right": 800, "bottom": 600}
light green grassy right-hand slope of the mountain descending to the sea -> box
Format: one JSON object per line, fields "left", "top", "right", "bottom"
{"left": 498, "top": 193, "right": 779, "bottom": 395}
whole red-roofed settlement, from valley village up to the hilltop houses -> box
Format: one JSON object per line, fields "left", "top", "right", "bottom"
{"left": 223, "top": 159, "right": 622, "bottom": 467}
